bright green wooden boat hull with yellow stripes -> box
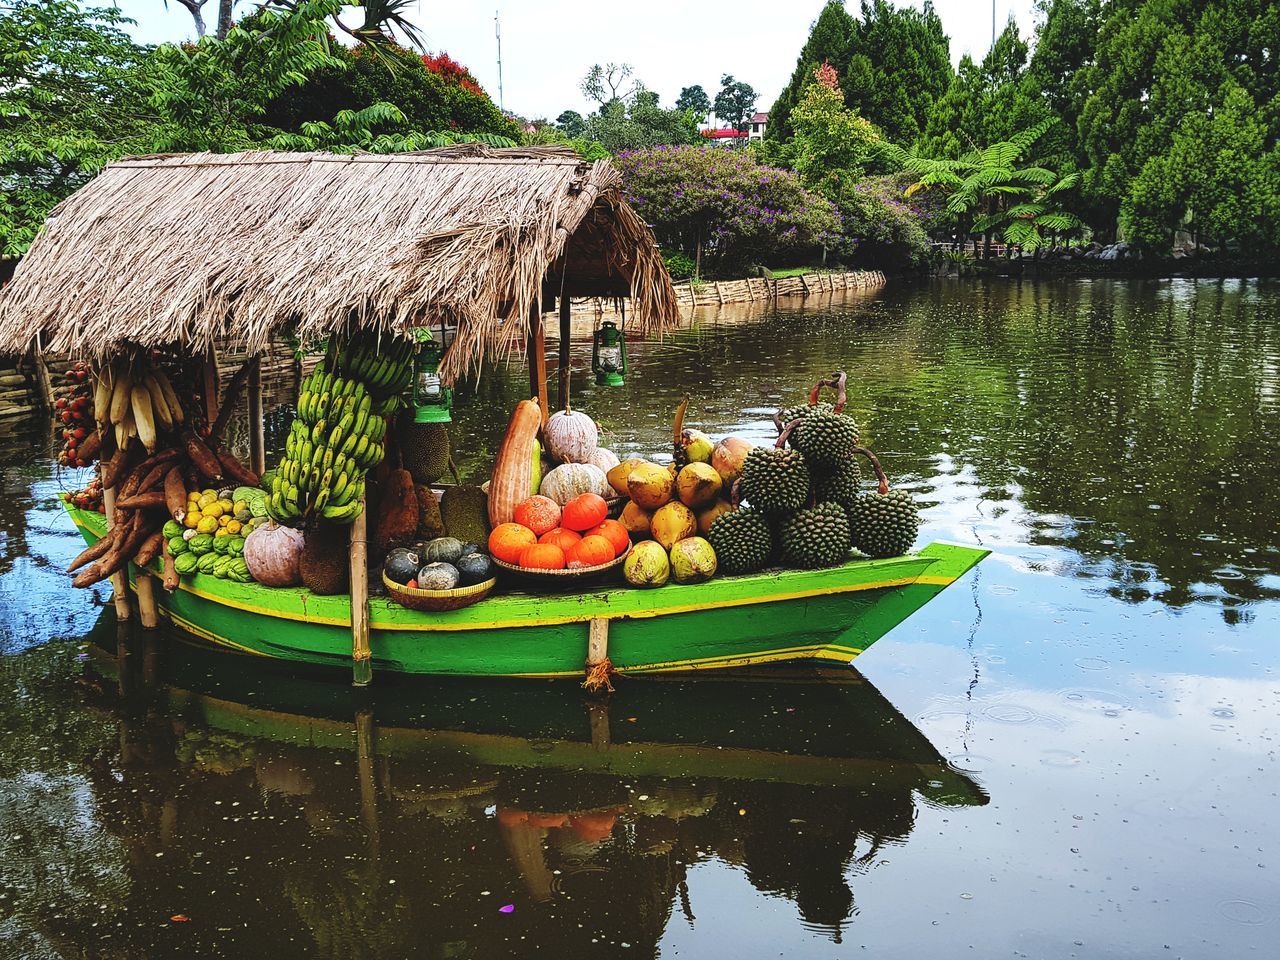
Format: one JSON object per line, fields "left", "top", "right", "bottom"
{"left": 69, "top": 508, "right": 988, "bottom": 677}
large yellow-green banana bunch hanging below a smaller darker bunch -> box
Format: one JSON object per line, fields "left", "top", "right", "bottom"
{"left": 266, "top": 365, "right": 387, "bottom": 524}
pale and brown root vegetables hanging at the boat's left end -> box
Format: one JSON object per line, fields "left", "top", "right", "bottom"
{"left": 67, "top": 352, "right": 259, "bottom": 590}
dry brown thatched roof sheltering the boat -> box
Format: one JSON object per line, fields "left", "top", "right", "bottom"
{"left": 0, "top": 145, "right": 677, "bottom": 376}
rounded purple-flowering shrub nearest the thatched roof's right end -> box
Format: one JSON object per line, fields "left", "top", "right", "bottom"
{"left": 617, "top": 146, "right": 840, "bottom": 269}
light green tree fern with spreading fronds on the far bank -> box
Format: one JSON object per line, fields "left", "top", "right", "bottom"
{"left": 882, "top": 118, "right": 1080, "bottom": 257}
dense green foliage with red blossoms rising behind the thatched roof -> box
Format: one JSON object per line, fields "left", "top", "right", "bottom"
{"left": 0, "top": 0, "right": 518, "bottom": 253}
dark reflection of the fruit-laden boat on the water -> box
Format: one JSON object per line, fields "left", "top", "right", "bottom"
{"left": 77, "top": 624, "right": 987, "bottom": 957}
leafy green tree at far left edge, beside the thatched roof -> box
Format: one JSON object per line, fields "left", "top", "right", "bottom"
{"left": 0, "top": 0, "right": 150, "bottom": 255}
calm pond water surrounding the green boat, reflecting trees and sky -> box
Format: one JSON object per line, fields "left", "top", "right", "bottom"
{"left": 0, "top": 282, "right": 1280, "bottom": 960}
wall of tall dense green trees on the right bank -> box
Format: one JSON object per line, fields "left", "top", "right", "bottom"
{"left": 768, "top": 0, "right": 1280, "bottom": 253}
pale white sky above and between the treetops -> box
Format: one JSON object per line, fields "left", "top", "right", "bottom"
{"left": 110, "top": 0, "right": 1033, "bottom": 119}
